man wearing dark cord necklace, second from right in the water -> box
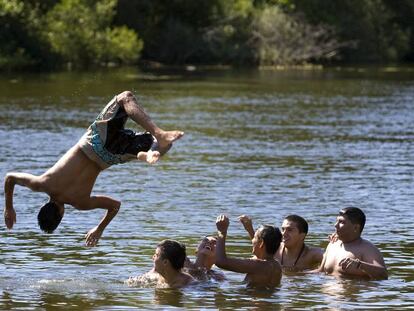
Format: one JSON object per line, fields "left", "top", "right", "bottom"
{"left": 239, "top": 215, "right": 323, "bottom": 272}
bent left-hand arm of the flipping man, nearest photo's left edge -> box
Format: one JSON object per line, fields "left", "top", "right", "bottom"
{"left": 4, "top": 173, "right": 40, "bottom": 229}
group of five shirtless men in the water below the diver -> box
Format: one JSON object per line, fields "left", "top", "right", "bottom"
{"left": 126, "top": 207, "right": 388, "bottom": 288}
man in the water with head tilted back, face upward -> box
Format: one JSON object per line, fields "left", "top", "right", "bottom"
{"left": 184, "top": 236, "right": 226, "bottom": 281}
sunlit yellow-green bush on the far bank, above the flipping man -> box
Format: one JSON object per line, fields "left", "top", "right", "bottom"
{"left": 44, "top": 0, "right": 142, "bottom": 67}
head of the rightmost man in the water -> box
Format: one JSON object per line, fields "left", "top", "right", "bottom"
{"left": 335, "top": 207, "right": 365, "bottom": 240}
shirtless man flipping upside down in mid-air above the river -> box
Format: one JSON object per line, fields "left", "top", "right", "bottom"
{"left": 4, "top": 91, "right": 184, "bottom": 246}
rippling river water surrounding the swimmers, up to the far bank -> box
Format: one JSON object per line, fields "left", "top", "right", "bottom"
{"left": 0, "top": 67, "right": 414, "bottom": 310}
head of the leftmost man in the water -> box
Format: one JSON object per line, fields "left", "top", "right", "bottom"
{"left": 152, "top": 240, "right": 187, "bottom": 274}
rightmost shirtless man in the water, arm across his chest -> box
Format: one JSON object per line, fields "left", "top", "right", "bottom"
{"left": 315, "top": 207, "right": 388, "bottom": 279}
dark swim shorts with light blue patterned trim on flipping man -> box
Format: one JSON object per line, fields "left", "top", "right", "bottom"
{"left": 78, "top": 96, "right": 154, "bottom": 169}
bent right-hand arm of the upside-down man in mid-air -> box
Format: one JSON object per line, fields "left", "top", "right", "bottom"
{"left": 76, "top": 196, "right": 121, "bottom": 246}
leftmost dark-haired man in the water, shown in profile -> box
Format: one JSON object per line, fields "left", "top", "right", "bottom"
{"left": 152, "top": 240, "right": 195, "bottom": 288}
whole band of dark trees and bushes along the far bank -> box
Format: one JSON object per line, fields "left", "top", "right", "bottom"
{"left": 0, "top": 0, "right": 414, "bottom": 70}
